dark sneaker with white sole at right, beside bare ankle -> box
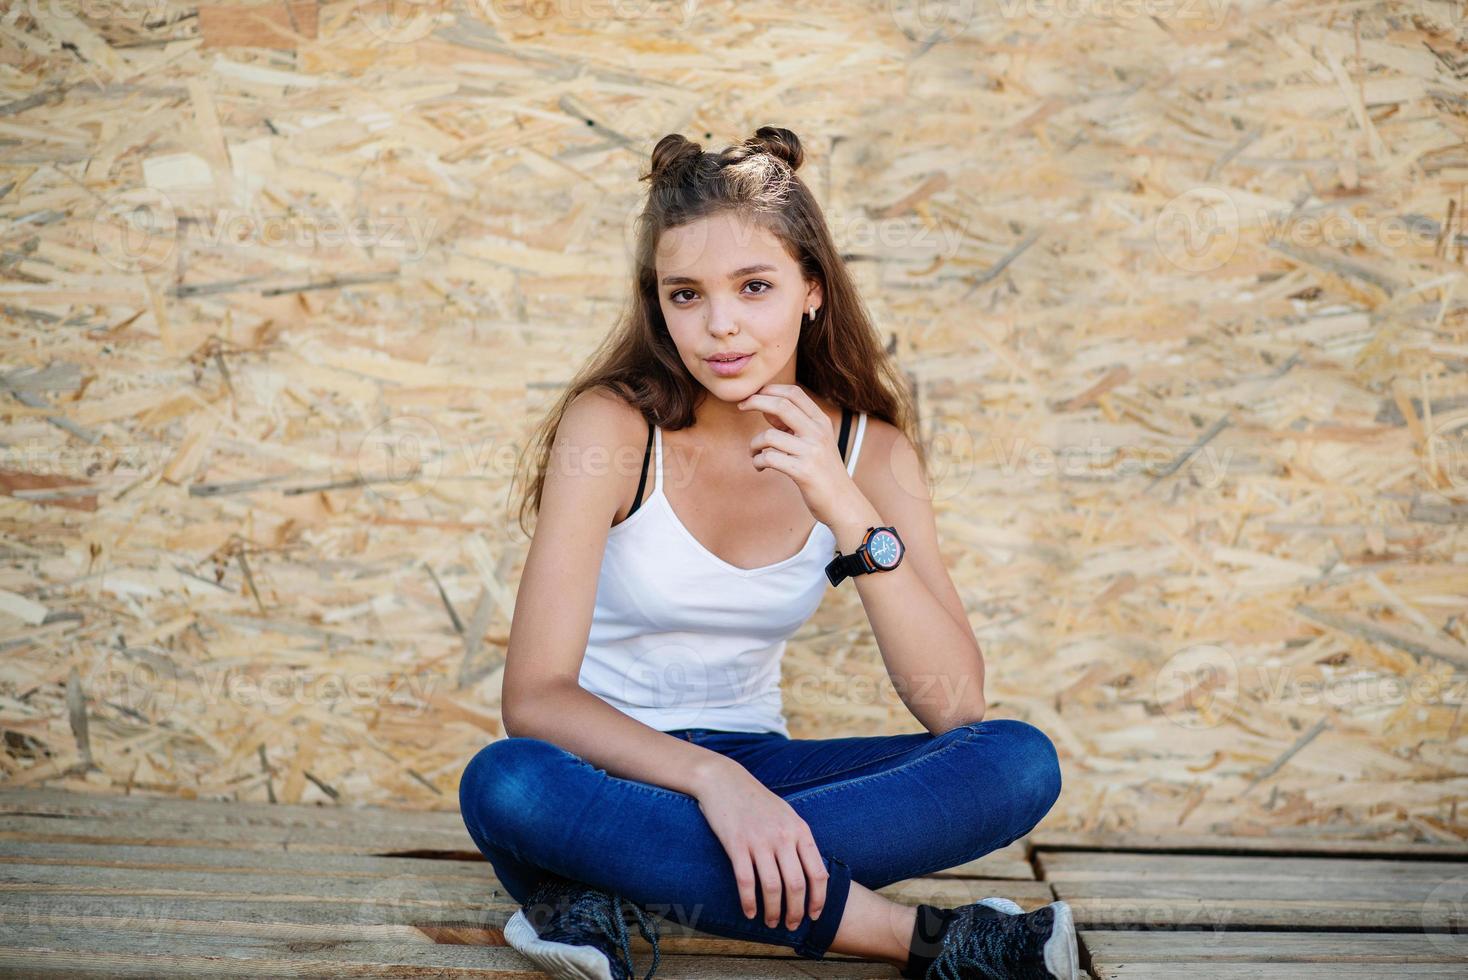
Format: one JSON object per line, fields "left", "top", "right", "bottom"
{"left": 926, "top": 899, "right": 1080, "bottom": 980}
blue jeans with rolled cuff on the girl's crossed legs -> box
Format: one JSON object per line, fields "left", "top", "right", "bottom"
{"left": 459, "top": 719, "right": 1060, "bottom": 959}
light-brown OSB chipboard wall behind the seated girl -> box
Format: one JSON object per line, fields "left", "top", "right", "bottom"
{"left": 0, "top": 0, "right": 1468, "bottom": 842}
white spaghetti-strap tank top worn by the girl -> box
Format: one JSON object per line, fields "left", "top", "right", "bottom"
{"left": 578, "top": 412, "right": 866, "bottom": 738}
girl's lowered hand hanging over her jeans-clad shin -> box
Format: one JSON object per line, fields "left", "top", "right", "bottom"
{"left": 696, "top": 763, "right": 831, "bottom": 929}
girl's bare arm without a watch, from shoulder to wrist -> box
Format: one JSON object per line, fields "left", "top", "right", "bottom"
{"left": 501, "top": 392, "right": 737, "bottom": 795}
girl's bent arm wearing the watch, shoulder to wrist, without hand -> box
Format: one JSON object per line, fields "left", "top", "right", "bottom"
{"left": 831, "top": 421, "right": 988, "bottom": 735}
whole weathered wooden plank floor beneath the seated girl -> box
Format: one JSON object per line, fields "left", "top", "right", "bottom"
{"left": 0, "top": 789, "right": 1468, "bottom": 980}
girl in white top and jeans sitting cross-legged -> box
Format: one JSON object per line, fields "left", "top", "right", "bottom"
{"left": 459, "top": 126, "right": 1078, "bottom": 980}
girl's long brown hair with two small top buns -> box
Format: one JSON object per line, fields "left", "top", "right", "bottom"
{"left": 517, "top": 126, "right": 928, "bottom": 534}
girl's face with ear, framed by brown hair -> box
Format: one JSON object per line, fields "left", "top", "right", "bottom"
{"left": 655, "top": 211, "right": 821, "bottom": 402}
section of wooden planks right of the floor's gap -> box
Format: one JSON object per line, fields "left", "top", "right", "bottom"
{"left": 1029, "top": 832, "right": 1468, "bottom": 980}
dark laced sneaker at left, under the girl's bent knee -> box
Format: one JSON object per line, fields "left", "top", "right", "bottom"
{"left": 505, "top": 876, "right": 661, "bottom": 980}
